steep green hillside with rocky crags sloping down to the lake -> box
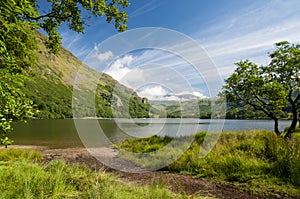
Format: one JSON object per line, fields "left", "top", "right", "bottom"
{"left": 24, "top": 33, "right": 150, "bottom": 119}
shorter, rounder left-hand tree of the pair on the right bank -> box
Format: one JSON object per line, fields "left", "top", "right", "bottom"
{"left": 222, "top": 60, "right": 286, "bottom": 135}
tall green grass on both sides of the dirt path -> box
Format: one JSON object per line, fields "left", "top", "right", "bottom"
{"left": 0, "top": 129, "right": 300, "bottom": 198}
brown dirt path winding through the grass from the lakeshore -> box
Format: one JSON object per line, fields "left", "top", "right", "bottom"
{"left": 10, "top": 146, "right": 298, "bottom": 199}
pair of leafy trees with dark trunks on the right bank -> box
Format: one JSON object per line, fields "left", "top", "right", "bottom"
{"left": 222, "top": 41, "right": 300, "bottom": 137}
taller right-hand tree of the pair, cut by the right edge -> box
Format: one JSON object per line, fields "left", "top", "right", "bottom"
{"left": 266, "top": 41, "right": 300, "bottom": 137}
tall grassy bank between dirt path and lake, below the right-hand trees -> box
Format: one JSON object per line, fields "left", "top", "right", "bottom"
{"left": 118, "top": 131, "right": 300, "bottom": 196}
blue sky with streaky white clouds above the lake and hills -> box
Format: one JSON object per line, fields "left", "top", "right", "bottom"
{"left": 46, "top": 0, "right": 300, "bottom": 99}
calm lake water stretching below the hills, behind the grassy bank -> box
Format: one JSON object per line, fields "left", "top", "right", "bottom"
{"left": 10, "top": 119, "right": 290, "bottom": 148}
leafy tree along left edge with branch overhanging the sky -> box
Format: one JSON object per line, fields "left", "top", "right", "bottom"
{"left": 0, "top": 0, "right": 129, "bottom": 147}
